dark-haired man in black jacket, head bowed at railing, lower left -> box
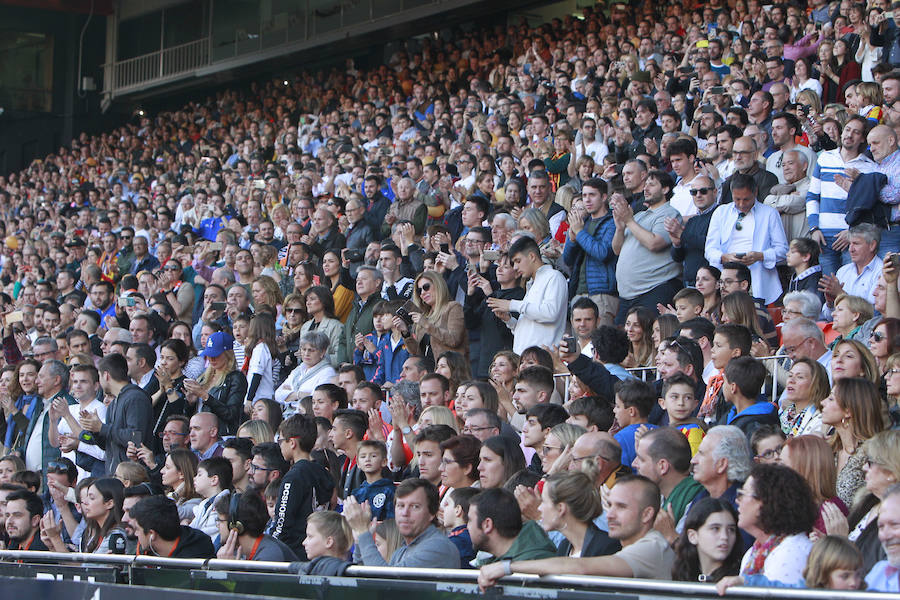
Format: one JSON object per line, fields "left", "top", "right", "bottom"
{"left": 125, "top": 496, "right": 216, "bottom": 558}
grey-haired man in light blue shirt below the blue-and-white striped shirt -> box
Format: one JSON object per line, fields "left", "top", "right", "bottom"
{"left": 819, "top": 223, "right": 884, "bottom": 317}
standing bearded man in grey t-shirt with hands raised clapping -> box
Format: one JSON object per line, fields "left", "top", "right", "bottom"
{"left": 612, "top": 170, "right": 681, "bottom": 324}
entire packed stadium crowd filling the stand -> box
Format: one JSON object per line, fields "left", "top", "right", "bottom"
{"left": 0, "top": 0, "right": 900, "bottom": 592}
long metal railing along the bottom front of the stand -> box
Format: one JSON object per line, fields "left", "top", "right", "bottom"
{"left": 0, "top": 550, "right": 897, "bottom": 600}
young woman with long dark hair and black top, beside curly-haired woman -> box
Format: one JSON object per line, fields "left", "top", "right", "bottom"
{"left": 672, "top": 498, "right": 744, "bottom": 583}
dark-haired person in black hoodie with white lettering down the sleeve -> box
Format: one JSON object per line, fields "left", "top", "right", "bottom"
{"left": 272, "top": 414, "right": 334, "bottom": 560}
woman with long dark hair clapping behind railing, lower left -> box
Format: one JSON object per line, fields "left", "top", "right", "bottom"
{"left": 41, "top": 476, "right": 126, "bottom": 554}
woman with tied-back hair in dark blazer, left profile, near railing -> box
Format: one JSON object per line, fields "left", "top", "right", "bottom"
{"left": 538, "top": 471, "right": 622, "bottom": 557}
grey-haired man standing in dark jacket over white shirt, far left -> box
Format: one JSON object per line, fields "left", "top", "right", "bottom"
{"left": 25, "top": 359, "right": 78, "bottom": 485}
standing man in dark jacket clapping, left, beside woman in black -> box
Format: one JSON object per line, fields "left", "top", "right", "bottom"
{"left": 79, "top": 354, "right": 153, "bottom": 476}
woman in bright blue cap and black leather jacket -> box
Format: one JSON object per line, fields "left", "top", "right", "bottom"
{"left": 184, "top": 331, "right": 247, "bottom": 436}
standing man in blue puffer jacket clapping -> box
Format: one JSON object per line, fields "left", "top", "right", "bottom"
{"left": 563, "top": 177, "right": 619, "bottom": 325}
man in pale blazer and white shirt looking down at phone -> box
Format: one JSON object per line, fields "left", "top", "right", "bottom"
{"left": 705, "top": 173, "right": 788, "bottom": 304}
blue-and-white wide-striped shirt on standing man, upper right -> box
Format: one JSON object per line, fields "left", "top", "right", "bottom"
{"left": 806, "top": 148, "right": 877, "bottom": 233}
